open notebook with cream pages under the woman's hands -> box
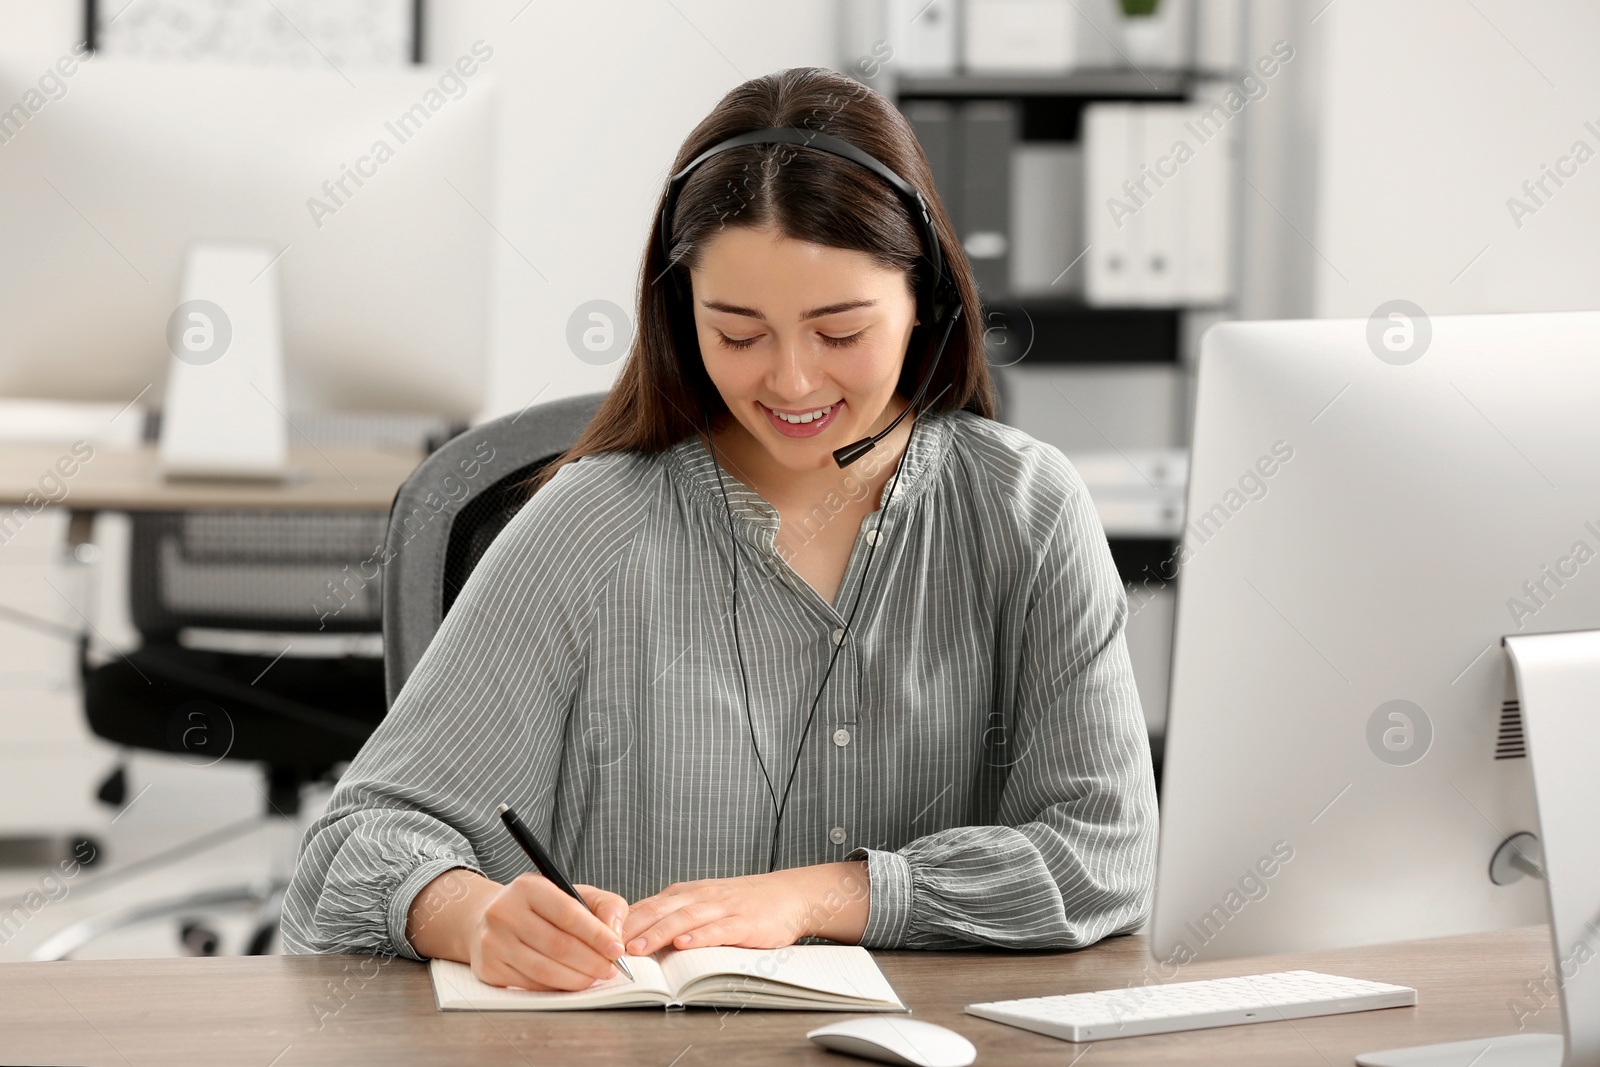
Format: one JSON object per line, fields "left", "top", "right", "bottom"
{"left": 427, "top": 945, "right": 907, "bottom": 1011}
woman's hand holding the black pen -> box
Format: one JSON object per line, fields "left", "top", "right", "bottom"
{"left": 406, "top": 867, "right": 627, "bottom": 990}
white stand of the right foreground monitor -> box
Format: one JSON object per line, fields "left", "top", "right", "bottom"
{"left": 1355, "top": 630, "right": 1600, "bottom": 1067}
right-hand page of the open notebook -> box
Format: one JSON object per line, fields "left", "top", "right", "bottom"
{"left": 658, "top": 945, "right": 904, "bottom": 1006}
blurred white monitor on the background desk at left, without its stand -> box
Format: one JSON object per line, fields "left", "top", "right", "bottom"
{"left": 0, "top": 50, "right": 499, "bottom": 419}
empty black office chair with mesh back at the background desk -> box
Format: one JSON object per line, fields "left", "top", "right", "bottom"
{"left": 32, "top": 416, "right": 459, "bottom": 960}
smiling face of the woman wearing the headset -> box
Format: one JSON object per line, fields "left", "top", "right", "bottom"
{"left": 690, "top": 227, "right": 917, "bottom": 472}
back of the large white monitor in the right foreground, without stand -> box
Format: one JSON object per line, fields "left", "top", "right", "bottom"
{"left": 1150, "top": 312, "right": 1600, "bottom": 1062}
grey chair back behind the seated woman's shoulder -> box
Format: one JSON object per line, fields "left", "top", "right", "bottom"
{"left": 382, "top": 394, "right": 605, "bottom": 705}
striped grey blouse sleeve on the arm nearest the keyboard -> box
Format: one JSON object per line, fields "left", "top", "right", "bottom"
{"left": 850, "top": 472, "right": 1157, "bottom": 949}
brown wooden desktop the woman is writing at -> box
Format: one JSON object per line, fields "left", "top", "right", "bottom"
{"left": 0, "top": 926, "right": 1560, "bottom": 1067}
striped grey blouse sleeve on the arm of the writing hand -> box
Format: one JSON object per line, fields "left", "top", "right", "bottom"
{"left": 282, "top": 462, "right": 629, "bottom": 960}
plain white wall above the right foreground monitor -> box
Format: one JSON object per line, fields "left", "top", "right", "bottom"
{"left": 1312, "top": 0, "right": 1600, "bottom": 317}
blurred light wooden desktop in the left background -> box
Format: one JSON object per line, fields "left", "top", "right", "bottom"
{"left": 0, "top": 443, "right": 422, "bottom": 514}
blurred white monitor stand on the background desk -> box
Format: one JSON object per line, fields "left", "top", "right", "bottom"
{"left": 158, "top": 242, "right": 288, "bottom": 482}
